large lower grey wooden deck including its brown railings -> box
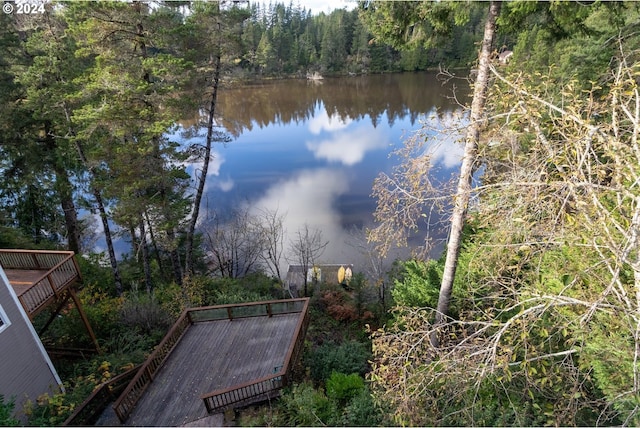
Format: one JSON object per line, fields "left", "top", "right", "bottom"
{"left": 111, "top": 299, "right": 308, "bottom": 426}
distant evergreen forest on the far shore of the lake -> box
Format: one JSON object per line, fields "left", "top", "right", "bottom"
{"left": 240, "top": 2, "right": 482, "bottom": 76}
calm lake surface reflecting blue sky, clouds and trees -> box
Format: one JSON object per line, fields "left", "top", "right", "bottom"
{"left": 182, "top": 73, "right": 468, "bottom": 270}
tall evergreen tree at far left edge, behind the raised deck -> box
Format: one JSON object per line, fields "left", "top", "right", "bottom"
{"left": 3, "top": 8, "right": 80, "bottom": 253}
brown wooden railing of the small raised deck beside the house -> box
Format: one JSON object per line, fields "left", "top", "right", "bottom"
{"left": 0, "top": 250, "right": 80, "bottom": 316}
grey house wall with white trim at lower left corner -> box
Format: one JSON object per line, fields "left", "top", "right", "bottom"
{"left": 0, "top": 267, "right": 61, "bottom": 420}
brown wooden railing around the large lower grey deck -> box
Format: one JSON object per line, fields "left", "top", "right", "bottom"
{"left": 113, "top": 298, "right": 309, "bottom": 423}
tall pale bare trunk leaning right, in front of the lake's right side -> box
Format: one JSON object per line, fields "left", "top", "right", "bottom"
{"left": 431, "top": 1, "right": 501, "bottom": 346}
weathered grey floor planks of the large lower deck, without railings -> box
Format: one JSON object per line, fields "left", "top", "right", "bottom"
{"left": 126, "top": 313, "right": 303, "bottom": 426}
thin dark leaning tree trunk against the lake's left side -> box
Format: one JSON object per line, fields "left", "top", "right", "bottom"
{"left": 184, "top": 30, "right": 222, "bottom": 275}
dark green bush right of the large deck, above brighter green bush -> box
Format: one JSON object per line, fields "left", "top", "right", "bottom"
{"left": 307, "top": 340, "right": 371, "bottom": 382}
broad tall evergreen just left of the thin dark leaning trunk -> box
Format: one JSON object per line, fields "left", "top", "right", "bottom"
{"left": 68, "top": 2, "right": 192, "bottom": 290}
